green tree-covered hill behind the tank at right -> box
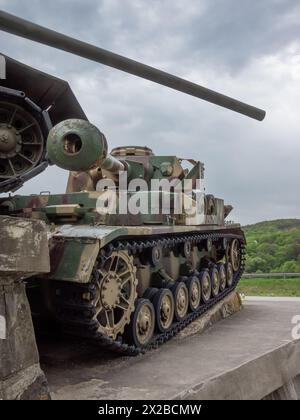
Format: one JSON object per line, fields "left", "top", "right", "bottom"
{"left": 244, "top": 219, "right": 300, "bottom": 273}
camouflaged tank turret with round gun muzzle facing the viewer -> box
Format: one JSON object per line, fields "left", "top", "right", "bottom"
{"left": 47, "top": 119, "right": 204, "bottom": 196}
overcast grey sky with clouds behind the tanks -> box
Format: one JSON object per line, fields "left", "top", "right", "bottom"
{"left": 0, "top": 0, "right": 300, "bottom": 224}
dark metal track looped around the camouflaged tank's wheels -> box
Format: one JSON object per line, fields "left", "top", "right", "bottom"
{"left": 51, "top": 233, "right": 245, "bottom": 356}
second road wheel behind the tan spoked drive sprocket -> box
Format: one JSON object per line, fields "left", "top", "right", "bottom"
{"left": 153, "top": 289, "right": 175, "bottom": 332}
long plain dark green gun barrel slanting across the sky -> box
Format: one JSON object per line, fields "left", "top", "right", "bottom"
{"left": 0, "top": 11, "right": 265, "bottom": 121}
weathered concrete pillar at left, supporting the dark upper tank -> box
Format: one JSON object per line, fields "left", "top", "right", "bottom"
{"left": 0, "top": 216, "right": 50, "bottom": 400}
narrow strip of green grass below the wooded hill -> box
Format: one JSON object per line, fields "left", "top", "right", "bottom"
{"left": 237, "top": 278, "right": 300, "bottom": 297}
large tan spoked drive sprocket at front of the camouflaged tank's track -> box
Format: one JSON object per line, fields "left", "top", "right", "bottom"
{"left": 94, "top": 251, "right": 137, "bottom": 339}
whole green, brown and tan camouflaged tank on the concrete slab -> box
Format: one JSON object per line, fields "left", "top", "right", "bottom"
{"left": 2, "top": 115, "right": 245, "bottom": 353}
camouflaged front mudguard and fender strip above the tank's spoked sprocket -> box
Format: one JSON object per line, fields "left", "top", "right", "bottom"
{"left": 50, "top": 224, "right": 241, "bottom": 283}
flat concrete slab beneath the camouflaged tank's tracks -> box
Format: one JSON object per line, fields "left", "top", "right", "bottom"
{"left": 40, "top": 295, "right": 300, "bottom": 400}
